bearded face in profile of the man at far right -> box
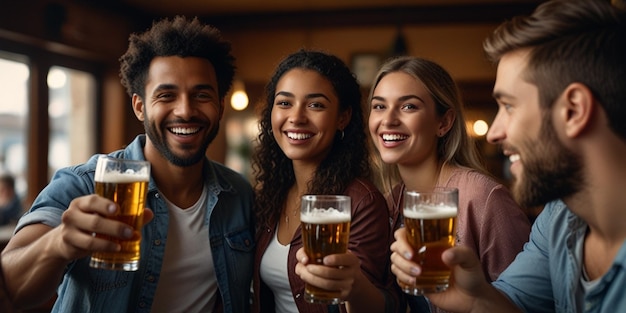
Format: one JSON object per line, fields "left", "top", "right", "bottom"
{"left": 487, "top": 50, "right": 584, "bottom": 207}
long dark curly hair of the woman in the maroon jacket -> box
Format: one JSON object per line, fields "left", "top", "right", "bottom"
{"left": 252, "top": 50, "right": 370, "bottom": 229}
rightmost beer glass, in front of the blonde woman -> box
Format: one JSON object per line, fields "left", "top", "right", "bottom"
{"left": 398, "top": 187, "right": 459, "bottom": 295}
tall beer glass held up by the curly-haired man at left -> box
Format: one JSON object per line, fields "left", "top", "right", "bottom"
{"left": 89, "top": 156, "right": 150, "bottom": 271}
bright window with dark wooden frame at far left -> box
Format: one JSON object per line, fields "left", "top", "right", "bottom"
{"left": 0, "top": 48, "right": 99, "bottom": 207}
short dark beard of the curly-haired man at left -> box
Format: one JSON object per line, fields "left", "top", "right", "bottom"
{"left": 143, "top": 119, "right": 220, "bottom": 167}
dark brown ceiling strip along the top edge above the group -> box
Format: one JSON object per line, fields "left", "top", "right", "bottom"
{"left": 114, "top": 0, "right": 543, "bottom": 29}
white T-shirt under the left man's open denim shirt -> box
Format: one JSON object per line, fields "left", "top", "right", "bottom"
{"left": 151, "top": 188, "right": 218, "bottom": 313}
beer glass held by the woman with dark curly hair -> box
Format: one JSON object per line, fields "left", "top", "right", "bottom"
{"left": 300, "top": 195, "right": 351, "bottom": 304}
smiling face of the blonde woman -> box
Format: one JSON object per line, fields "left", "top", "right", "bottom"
{"left": 369, "top": 72, "right": 448, "bottom": 166}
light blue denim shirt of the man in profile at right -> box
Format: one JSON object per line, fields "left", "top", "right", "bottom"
{"left": 493, "top": 201, "right": 626, "bottom": 313}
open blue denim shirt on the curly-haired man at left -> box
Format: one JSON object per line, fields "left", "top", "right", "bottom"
{"left": 16, "top": 135, "right": 255, "bottom": 313}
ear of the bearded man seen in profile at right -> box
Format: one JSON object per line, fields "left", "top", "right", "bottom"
{"left": 559, "top": 83, "right": 595, "bottom": 137}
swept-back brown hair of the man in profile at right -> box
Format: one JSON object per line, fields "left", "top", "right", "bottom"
{"left": 483, "top": 0, "right": 626, "bottom": 140}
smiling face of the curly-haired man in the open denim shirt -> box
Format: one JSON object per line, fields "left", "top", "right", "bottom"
{"left": 133, "top": 56, "right": 223, "bottom": 167}
